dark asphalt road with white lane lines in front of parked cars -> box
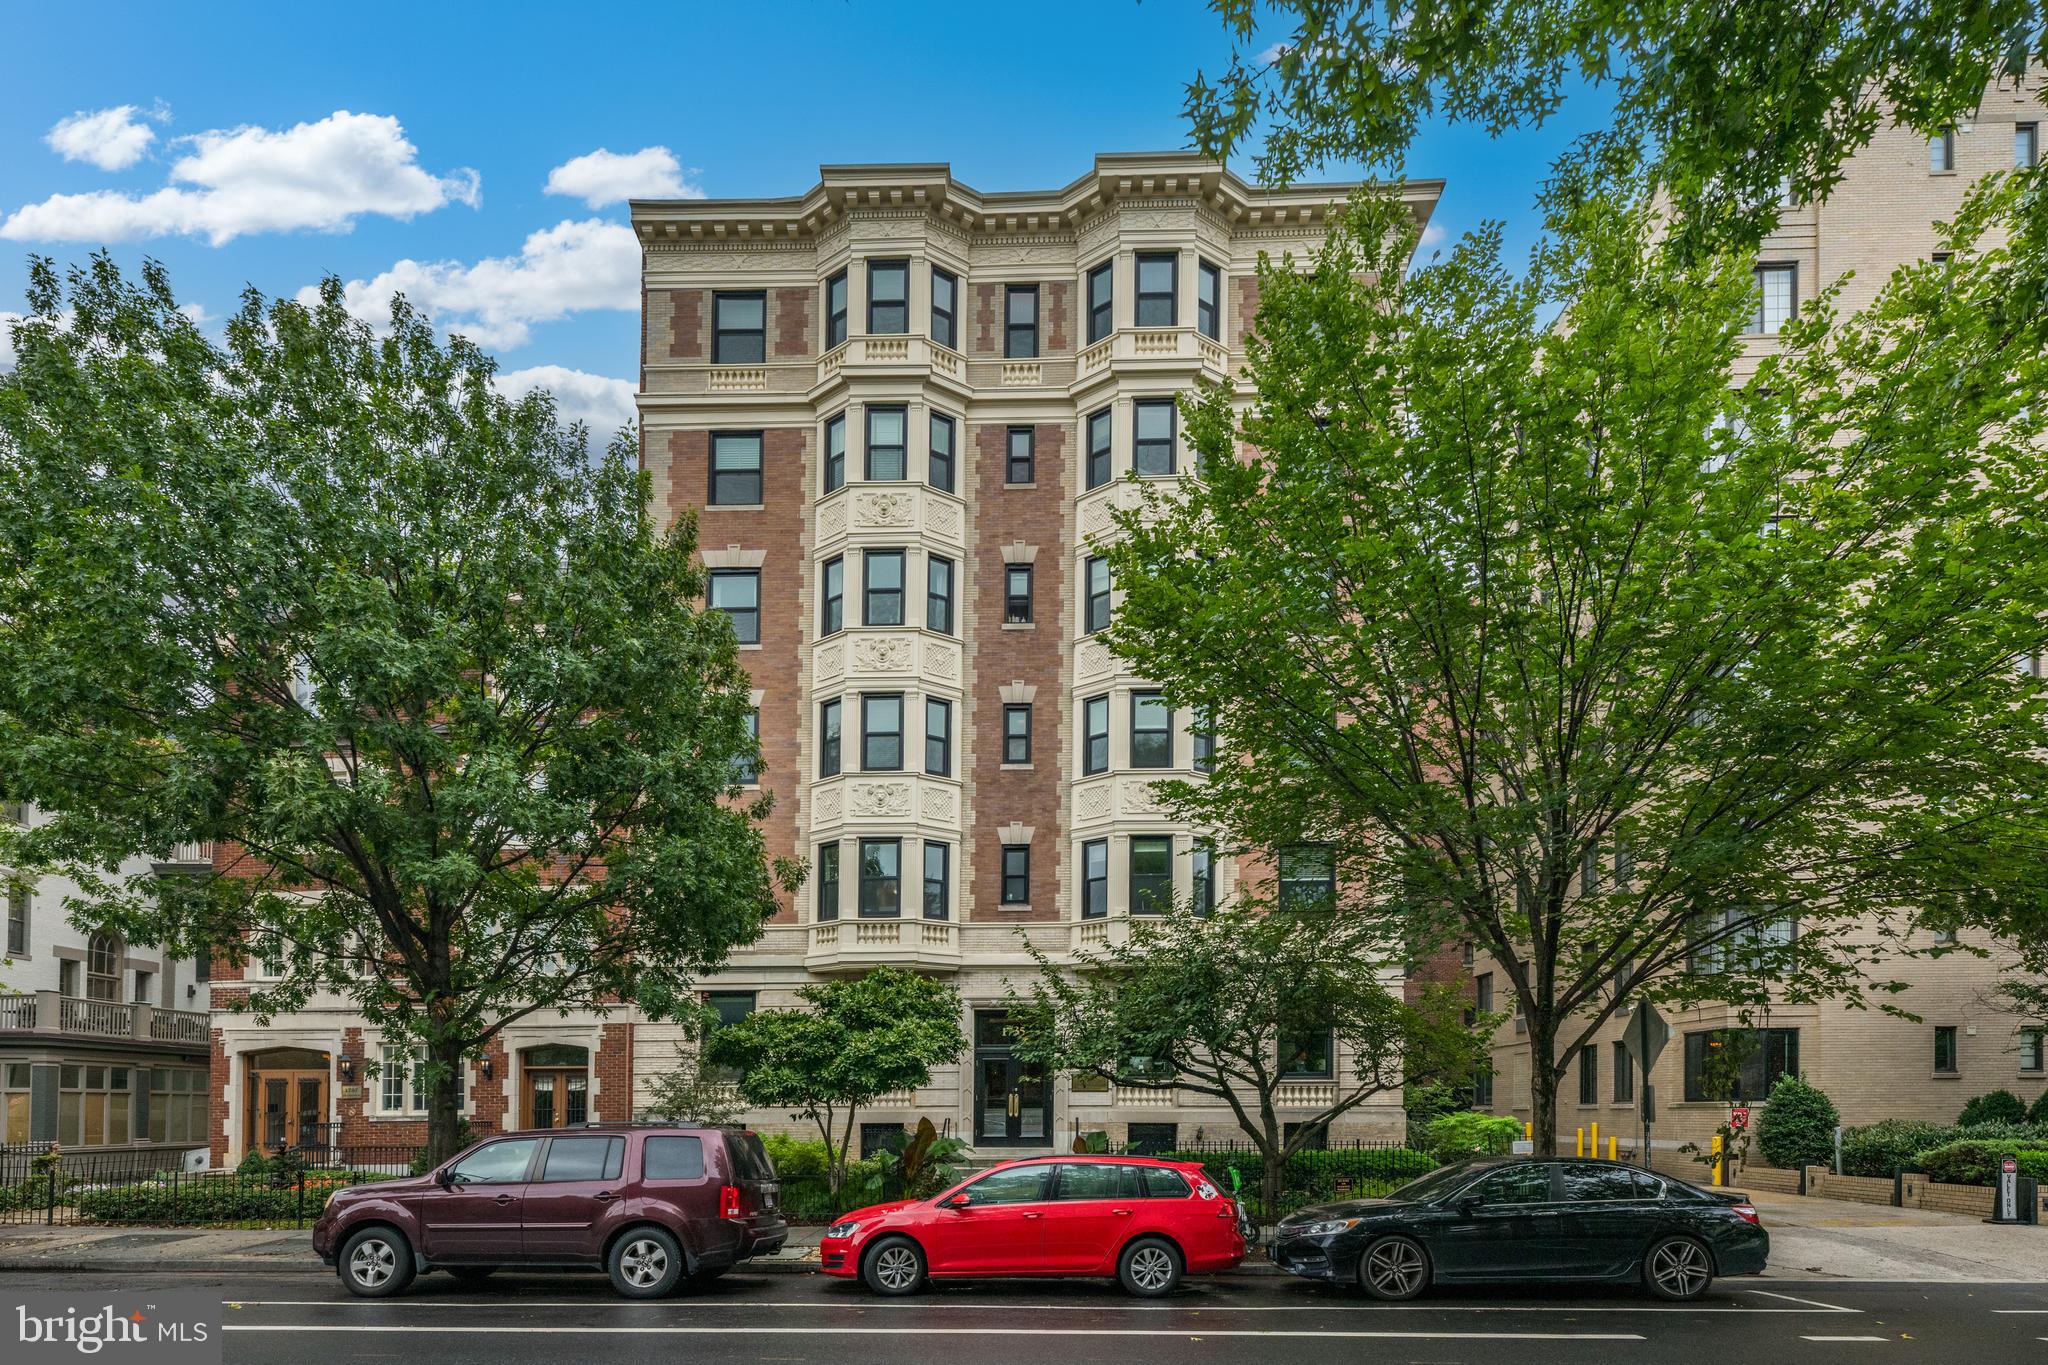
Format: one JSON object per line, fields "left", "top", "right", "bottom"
{"left": 16, "top": 1271, "right": 2048, "bottom": 1365}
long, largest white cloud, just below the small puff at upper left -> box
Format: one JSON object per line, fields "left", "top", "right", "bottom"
{"left": 0, "top": 111, "right": 481, "bottom": 246}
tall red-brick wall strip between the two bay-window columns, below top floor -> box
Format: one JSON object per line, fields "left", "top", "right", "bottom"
{"left": 963, "top": 424, "right": 1073, "bottom": 921}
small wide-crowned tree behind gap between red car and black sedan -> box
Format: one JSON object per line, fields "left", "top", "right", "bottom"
{"left": 1010, "top": 898, "right": 1477, "bottom": 1209}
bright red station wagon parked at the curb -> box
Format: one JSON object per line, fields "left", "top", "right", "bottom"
{"left": 819, "top": 1156, "right": 1247, "bottom": 1297}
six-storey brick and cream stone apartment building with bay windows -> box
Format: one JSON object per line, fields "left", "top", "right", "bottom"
{"left": 633, "top": 153, "right": 1440, "bottom": 1150}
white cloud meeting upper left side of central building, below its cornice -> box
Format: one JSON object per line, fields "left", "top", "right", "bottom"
{"left": 311, "top": 219, "right": 641, "bottom": 350}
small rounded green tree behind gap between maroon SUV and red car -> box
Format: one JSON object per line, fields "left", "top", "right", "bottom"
{"left": 705, "top": 966, "right": 967, "bottom": 1193}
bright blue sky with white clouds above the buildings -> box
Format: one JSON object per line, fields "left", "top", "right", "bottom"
{"left": 0, "top": 0, "right": 1597, "bottom": 424}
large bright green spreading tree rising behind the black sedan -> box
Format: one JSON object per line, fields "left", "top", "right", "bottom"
{"left": 1106, "top": 172, "right": 2048, "bottom": 1150}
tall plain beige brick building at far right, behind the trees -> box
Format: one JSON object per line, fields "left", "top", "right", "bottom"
{"left": 1470, "top": 82, "right": 2048, "bottom": 1152}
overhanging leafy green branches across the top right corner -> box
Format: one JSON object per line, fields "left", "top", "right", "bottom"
{"left": 1186, "top": 0, "right": 2048, "bottom": 239}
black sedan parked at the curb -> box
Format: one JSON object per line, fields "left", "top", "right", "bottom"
{"left": 1268, "top": 1156, "right": 1772, "bottom": 1300}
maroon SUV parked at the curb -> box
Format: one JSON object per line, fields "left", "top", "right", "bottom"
{"left": 313, "top": 1124, "right": 788, "bottom": 1300}
